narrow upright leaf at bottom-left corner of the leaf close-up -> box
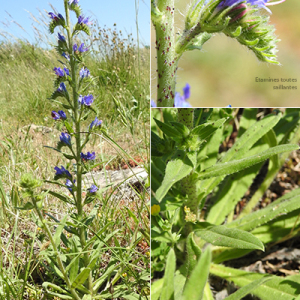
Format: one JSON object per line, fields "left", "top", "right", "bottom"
{"left": 160, "top": 249, "right": 176, "bottom": 300}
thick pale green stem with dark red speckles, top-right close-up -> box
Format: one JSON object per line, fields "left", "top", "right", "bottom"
{"left": 151, "top": 0, "right": 178, "bottom": 107}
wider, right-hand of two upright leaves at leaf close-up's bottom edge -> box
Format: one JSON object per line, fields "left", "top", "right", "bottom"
{"left": 182, "top": 247, "right": 211, "bottom": 300}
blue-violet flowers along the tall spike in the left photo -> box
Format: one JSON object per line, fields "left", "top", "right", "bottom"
{"left": 49, "top": 0, "right": 102, "bottom": 202}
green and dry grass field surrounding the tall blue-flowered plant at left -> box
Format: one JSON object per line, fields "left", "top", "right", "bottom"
{"left": 0, "top": 3, "right": 150, "bottom": 300}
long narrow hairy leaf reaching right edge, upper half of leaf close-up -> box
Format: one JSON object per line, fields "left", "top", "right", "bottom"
{"left": 198, "top": 145, "right": 299, "bottom": 179}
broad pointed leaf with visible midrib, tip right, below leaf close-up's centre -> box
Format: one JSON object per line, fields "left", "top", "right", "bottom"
{"left": 194, "top": 222, "right": 264, "bottom": 251}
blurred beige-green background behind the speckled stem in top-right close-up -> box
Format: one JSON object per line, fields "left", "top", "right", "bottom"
{"left": 151, "top": 0, "right": 300, "bottom": 107}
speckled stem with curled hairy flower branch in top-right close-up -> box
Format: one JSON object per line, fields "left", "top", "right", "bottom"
{"left": 151, "top": 0, "right": 285, "bottom": 107}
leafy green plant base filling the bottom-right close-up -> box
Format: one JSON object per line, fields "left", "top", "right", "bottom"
{"left": 151, "top": 108, "right": 300, "bottom": 300}
